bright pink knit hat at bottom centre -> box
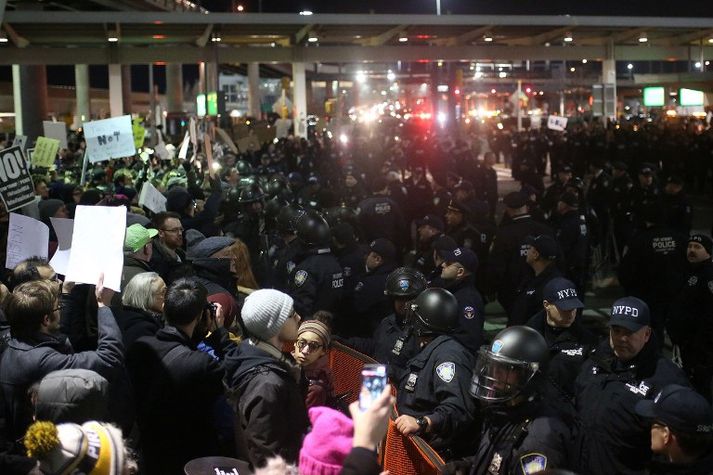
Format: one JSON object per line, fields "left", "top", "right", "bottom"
{"left": 299, "top": 407, "right": 354, "bottom": 475}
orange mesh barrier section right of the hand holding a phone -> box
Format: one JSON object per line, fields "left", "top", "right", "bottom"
{"left": 380, "top": 408, "right": 445, "bottom": 475}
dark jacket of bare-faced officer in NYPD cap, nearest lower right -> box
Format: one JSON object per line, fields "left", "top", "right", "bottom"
{"left": 575, "top": 340, "right": 688, "bottom": 475}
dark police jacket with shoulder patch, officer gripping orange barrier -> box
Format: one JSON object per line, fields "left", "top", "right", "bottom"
{"left": 396, "top": 335, "right": 475, "bottom": 458}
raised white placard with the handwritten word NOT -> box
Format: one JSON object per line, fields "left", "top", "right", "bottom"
{"left": 84, "top": 115, "right": 136, "bottom": 162}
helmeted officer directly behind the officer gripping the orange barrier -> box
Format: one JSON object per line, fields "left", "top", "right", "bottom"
{"left": 344, "top": 267, "right": 426, "bottom": 381}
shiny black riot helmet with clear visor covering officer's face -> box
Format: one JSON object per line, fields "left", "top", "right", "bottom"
{"left": 470, "top": 326, "right": 548, "bottom": 404}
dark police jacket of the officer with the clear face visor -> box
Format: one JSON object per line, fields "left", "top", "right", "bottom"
{"left": 470, "top": 400, "right": 572, "bottom": 475}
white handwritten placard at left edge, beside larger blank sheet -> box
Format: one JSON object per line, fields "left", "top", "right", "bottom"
{"left": 5, "top": 213, "right": 50, "bottom": 269}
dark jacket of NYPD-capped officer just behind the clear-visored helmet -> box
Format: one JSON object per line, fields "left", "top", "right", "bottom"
{"left": 527, "top": 309, "right": 597, "bottom": 400}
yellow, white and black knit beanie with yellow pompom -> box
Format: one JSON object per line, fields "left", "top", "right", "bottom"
{"left": 23, "top": 421, "right": 125, "bottom": 475}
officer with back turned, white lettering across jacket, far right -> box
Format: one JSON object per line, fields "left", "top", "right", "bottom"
{"left": 618, "top": 203, "right": 688, "bottom": 345}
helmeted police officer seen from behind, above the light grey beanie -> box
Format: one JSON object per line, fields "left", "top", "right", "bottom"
{"left": 288, "top": 209, "right": 344, "bottom": 325}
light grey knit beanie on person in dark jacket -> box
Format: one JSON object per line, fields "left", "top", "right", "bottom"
{"left": 240, "top": 289, "right": 294, "bottom": 341}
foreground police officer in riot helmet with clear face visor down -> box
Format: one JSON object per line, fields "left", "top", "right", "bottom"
{"left": 451, "top": 326, "right": 573, "bottom": 475}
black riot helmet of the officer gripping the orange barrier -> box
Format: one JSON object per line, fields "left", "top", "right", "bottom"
{"left": 411, "top": 287, "right": 459, "bottom": 336}
